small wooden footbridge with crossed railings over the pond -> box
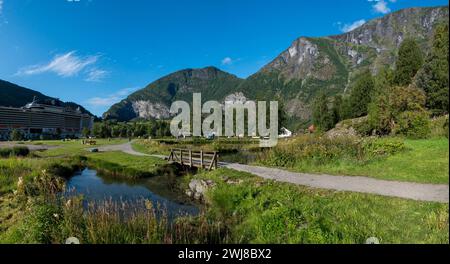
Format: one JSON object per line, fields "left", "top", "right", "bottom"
{"left": 168, "top": 149, "right": 219, "bottom": 170}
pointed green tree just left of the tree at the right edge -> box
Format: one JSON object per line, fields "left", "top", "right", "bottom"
{"left": 394, "top": 39, "right": 423, "bottom": 86}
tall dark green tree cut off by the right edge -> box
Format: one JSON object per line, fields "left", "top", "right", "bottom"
{"left": 416, "top": 24, "right": 449, "bottom": 114}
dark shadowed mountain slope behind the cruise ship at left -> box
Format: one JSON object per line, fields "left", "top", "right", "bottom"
{"left": 0, "top": 80, "right": 93, "bottom": 116}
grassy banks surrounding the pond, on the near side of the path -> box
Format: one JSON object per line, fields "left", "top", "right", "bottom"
{"left": 0, "top": 139, "right": 449, "bottom": 244}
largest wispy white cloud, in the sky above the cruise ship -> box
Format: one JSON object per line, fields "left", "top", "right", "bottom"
{"left": 17, "top": 51, "right": 99, "bottom": 77}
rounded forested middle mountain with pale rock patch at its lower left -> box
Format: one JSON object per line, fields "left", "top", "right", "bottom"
{"left": 103, "top": 67, "right": 243, "bottom": 121}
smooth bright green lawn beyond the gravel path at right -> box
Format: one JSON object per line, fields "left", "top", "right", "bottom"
{"left": 292, "top": 138, "right": 449, "bottom": 184}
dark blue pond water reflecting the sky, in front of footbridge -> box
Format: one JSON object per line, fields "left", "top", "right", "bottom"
{"left": 66, "top": 169, "right": 199, "bottom": 218}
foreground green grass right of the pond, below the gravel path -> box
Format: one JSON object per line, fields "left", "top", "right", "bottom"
{"left": 193, "top": 169, "right": 449, "bottom": 244}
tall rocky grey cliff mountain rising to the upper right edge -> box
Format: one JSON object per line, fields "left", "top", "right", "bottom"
{"left": 239, "top": 7, "right": 448, "bottom": 128}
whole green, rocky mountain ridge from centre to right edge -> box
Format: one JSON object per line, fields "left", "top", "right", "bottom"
{"left": 104, "top": 6, "right": 448, "bottom": 129}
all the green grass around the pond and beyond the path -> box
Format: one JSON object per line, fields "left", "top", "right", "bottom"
{"left": 0, "top": 136, "right": 449, "bottom": 244}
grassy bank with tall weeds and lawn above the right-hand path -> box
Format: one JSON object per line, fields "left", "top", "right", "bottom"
{"left": 258, "top": 136, "right": 449, "bottom": 184}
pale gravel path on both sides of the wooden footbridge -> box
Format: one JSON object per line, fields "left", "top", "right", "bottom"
{"left": 99, "top": 142, "right": 449, "bottom": 203}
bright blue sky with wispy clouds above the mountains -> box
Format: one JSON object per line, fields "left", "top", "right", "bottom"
{"left": 0, "top": 0, "right": 448, "bottom": 115}
